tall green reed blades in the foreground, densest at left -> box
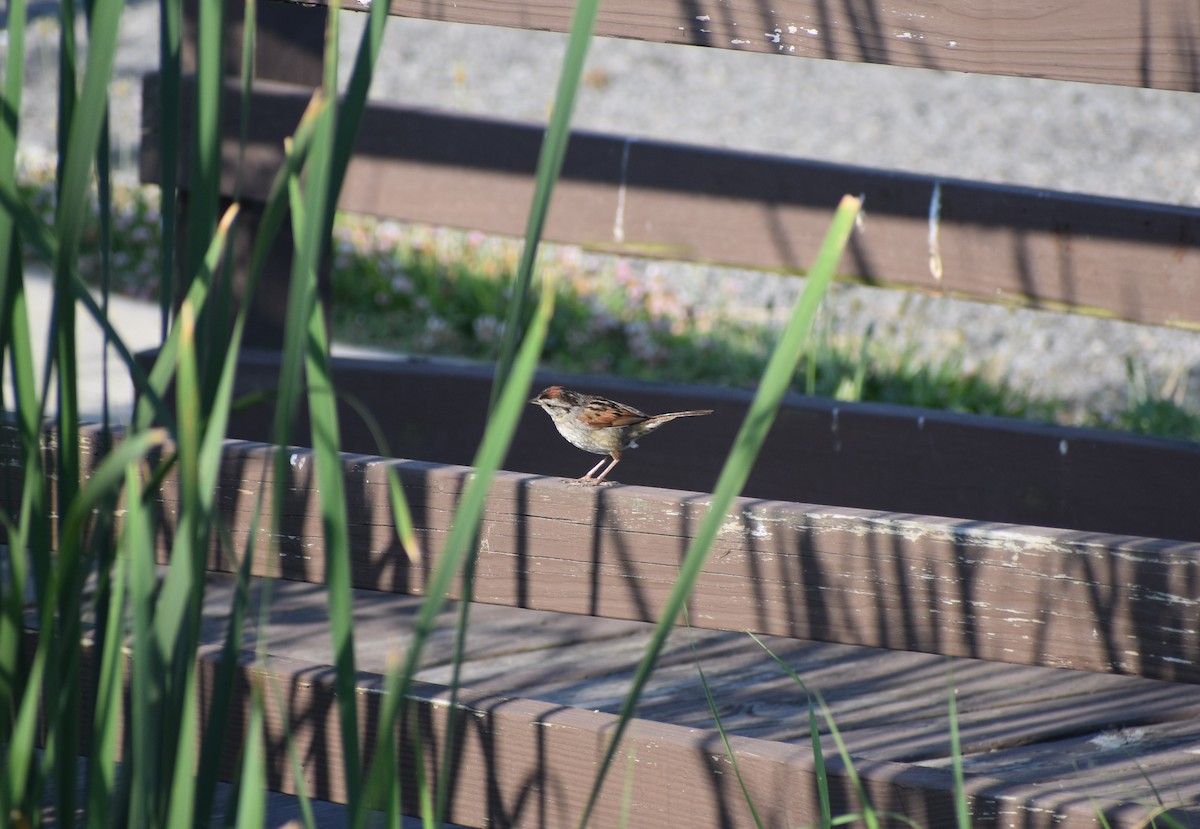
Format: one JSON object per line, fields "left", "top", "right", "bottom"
{"left": 0, "top": 0, "right": 858, "bottom": 827}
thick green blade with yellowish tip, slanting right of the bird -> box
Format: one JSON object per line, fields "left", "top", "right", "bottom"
{"left": 580, "top": 196, "right": 860, "bottom": 827}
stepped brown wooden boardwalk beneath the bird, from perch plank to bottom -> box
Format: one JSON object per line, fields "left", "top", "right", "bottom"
{"left": 14, "top": 398, "right": 1200, "bottom": 829}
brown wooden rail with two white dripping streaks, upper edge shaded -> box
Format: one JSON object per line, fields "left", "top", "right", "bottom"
{"left": 142, "top": 78, "right": 1200, "bottom": 326}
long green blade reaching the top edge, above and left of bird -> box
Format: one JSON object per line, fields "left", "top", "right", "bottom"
{"left": 488, "top": 0, "right": 600, "bottom": 409}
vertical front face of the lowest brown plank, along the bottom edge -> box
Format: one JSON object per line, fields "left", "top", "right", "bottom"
{"left": 42, "top": 630, "right": 1198, "bottom": 829}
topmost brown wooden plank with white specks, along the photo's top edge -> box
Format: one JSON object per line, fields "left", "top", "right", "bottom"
{"left": 290, "top": 0, "right": 1200, "bottom": 97}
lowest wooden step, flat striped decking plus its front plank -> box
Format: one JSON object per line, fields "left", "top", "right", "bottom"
{"left": 42, "top": 575, "right": 1200, "bottom": 829}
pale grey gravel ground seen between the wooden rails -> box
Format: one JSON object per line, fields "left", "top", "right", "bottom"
{"left": 14, "top": 0, "right": 1200, "bottom": 422}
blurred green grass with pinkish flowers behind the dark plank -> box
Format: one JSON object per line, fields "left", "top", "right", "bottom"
{"left": 22, "top": 154, "right": 1200, "bottom": 440}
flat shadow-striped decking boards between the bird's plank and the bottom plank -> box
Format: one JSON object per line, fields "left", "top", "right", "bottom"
{"left": 208, "top": 576, "right": 1200, "bottom": 798}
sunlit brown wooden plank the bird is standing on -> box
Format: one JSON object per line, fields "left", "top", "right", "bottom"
{"left": 110, "top": 424, "right": 1200, "bottom": 681}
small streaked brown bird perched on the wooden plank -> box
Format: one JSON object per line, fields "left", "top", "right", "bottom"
{"left": 529, "top": 386, "right": 713, "bottom": 483}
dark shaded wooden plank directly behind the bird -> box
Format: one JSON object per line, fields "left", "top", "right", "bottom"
{"left": 208, "top": 353, "right": 1200, "bottom": 541}
